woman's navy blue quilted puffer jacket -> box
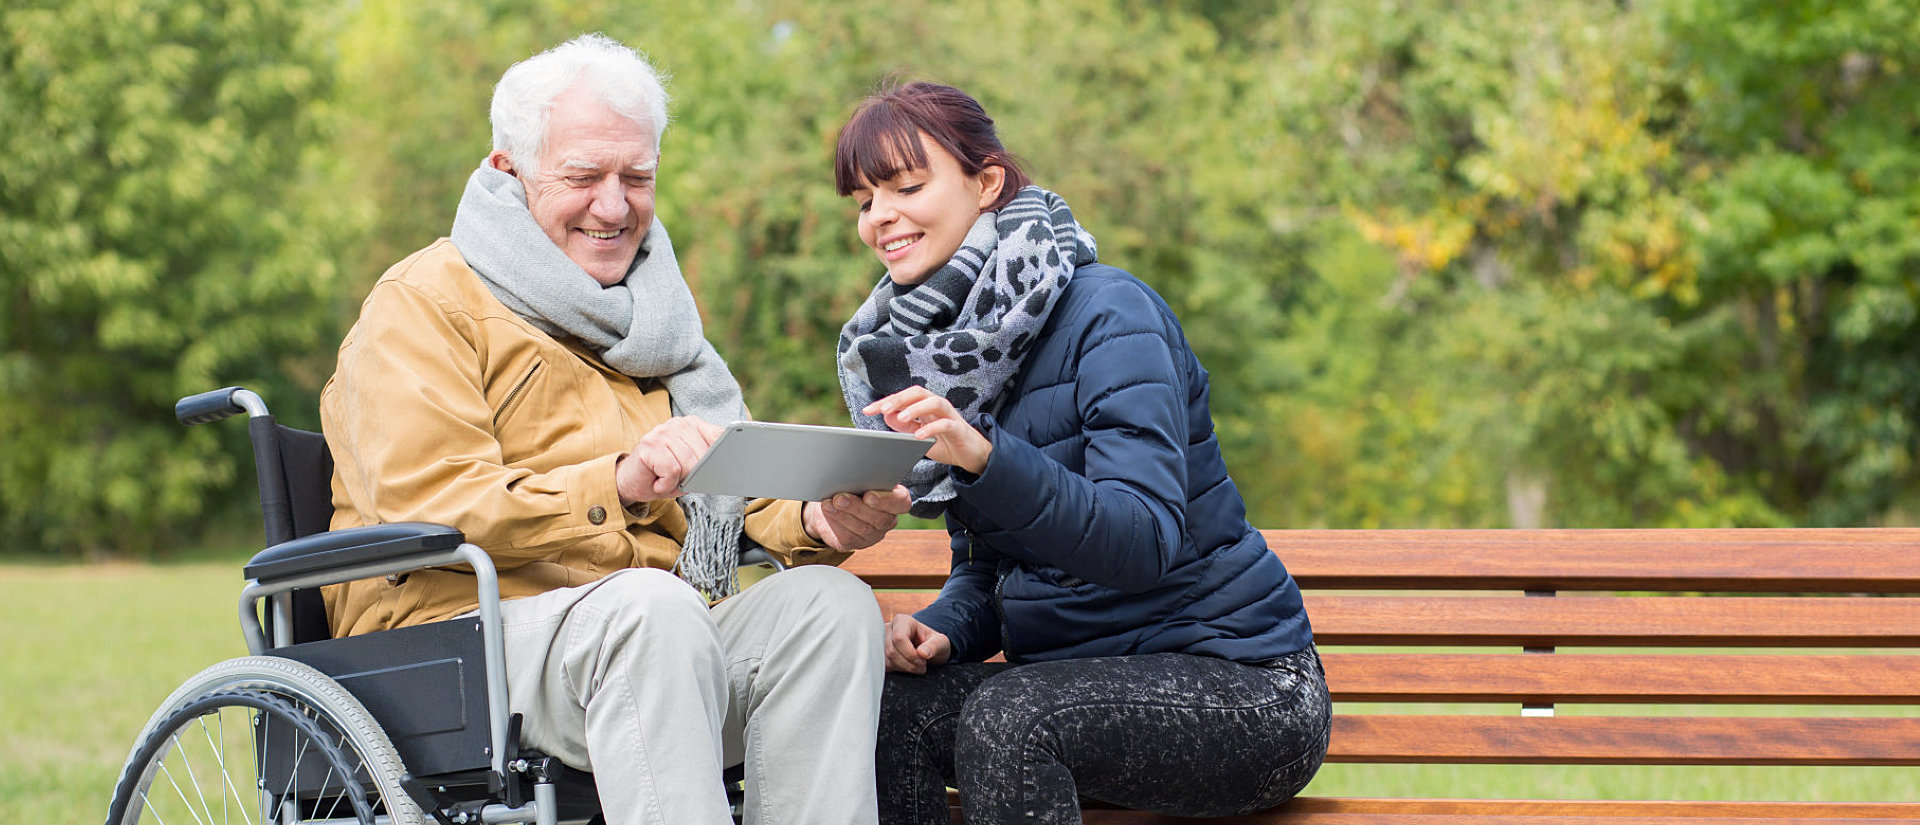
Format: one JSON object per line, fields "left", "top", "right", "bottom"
{"left": 916, "top": 265, "right": 1313, "bottom": 662}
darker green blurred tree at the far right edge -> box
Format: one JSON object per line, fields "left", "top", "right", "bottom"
{"left": 1661, "top": 0, "right": 1920, "bottom": 524}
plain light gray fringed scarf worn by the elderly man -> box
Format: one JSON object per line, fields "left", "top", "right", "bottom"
{"left": 453, "top": 165, "right": 747, "bottom": 599}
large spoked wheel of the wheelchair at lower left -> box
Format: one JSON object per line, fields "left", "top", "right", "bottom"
{"left": 108, "top": 656, "right": 424, "bottom": 825}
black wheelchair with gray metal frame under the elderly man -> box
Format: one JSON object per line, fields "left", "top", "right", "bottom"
{"left": 108, "top": 388, "right": 778, "bottom": 825}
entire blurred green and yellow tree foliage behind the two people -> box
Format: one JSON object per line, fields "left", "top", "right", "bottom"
{"left": 0, "top": 0, "right": 1920, "bottom": 554}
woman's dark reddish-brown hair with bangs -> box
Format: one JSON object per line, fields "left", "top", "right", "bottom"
{"left": 833, "top": 81, "right": 1033, "bottom": 211}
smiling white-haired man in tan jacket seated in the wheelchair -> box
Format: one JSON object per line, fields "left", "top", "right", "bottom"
{"left": 321, "top": 35, "right": 906, "bottom": 825}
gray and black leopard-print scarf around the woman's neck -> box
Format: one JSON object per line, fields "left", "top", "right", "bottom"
{"left": 839, "top": 186, "right": 1096, "bottom": 518}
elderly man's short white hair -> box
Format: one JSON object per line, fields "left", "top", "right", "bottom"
{"left": 490, "top": 33, "right": 666, "bottom": 173}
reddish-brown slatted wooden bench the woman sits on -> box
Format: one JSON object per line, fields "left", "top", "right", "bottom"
{"left": 847, "top": 530, "right": 1920, "bottom": 825}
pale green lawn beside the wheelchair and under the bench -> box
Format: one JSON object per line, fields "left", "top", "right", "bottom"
{"left": 0, "top": 560, "right": 1920, "bottom": 823}
